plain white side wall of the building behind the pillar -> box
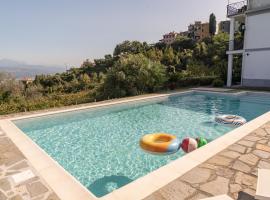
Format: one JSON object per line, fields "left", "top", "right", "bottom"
{"left": 242, "top": 11, "right": 270, "bottom": 87}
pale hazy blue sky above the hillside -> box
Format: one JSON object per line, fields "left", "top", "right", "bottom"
{"left": 0, "top": 0, "right": 227, "bottom": 66}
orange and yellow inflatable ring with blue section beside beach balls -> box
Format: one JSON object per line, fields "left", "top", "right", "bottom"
{"left": 140, "top": 133, "right": 180, "bottom": 155}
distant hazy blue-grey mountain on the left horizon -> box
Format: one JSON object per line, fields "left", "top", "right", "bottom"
{"left": 0, "top": 59, "right": 66, "bottom": 78}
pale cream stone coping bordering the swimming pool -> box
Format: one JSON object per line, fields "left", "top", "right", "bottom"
{"left": 0, "top": 90, "right": 270, "bottom": 200}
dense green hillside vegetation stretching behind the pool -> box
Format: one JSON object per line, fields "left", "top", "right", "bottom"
{"left": 0, "top": 23, "right": 245, "bottom": 114}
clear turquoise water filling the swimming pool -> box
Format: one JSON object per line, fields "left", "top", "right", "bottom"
{"left": 15, "top": 92, "right": 270, "bottom": 197}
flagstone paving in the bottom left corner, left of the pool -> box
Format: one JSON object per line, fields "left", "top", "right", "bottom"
{"left": 0, "top": 129, "right": 59, "bottom": 200}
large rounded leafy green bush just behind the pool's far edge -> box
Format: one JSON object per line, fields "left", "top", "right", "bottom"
{"left": 99, "top": 54, "right": 166, "bottom": 98}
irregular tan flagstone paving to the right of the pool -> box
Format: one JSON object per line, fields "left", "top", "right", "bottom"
{"left": 145, "top": 122, "right": 270, "bottom": 200}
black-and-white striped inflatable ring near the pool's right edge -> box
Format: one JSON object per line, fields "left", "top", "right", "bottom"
{"left": 215, "top": 115, "right": 247, "bottom": 126}
